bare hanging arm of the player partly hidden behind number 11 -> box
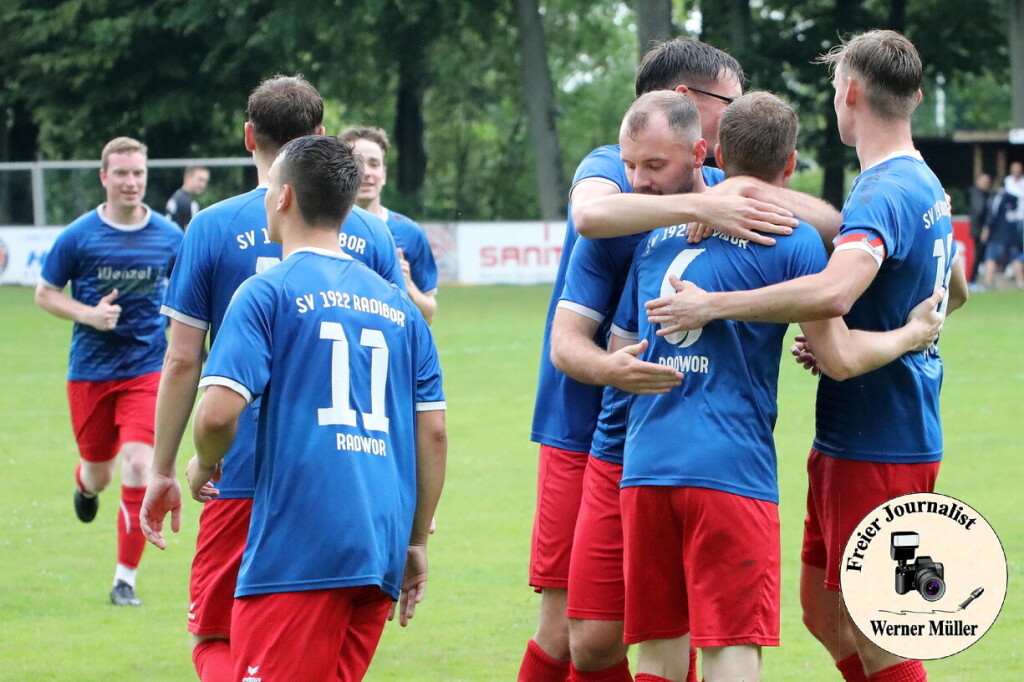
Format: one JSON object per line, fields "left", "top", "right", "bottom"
{"left": 139, "top": 318, "right": 206, "bottom": 549}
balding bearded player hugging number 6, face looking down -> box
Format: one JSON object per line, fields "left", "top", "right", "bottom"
{"left": 552, "top": 90, "right": 722, "bottom": 682}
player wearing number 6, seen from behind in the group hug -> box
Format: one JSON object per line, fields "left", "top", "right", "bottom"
{"left": 606, "top": 92, "right": 942, "bottom": 682}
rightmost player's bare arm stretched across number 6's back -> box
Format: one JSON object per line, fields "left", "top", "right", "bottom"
{"left": 646, "top": 249, "right": 879, "bottom": 336}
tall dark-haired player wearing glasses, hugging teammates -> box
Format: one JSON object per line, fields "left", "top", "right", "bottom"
{"left": 520, "top": 39, "right": 838, "bottom": 680}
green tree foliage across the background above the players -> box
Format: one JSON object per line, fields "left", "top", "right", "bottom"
{"left": 0, "top": 0, "right": 1010, "bottom": 219}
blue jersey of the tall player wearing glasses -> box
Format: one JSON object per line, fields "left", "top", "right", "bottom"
{"left": 530, "top": 144, "right": 633, "bottom": 453}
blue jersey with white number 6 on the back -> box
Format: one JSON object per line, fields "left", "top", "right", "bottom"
{"left": 613, "top": 223, "right": 826, "bottom": 503}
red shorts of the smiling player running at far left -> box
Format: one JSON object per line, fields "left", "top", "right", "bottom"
{"left": 68, "top": 372, "right": 160, "bottom": 462}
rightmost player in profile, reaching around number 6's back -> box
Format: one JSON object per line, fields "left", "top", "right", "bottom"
{"left": 647, "top": 31, "right": 968, "bottom": 681}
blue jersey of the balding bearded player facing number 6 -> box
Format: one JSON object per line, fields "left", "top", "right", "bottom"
{"left": 558, "top": 167, "right": 725, "bottom": 464}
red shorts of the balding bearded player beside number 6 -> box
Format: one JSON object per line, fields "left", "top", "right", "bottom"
{"left": 566, "top": 457, "right": 626, "bottom": 621}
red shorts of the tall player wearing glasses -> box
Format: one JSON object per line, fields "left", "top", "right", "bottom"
{"left": 529, "top": 445, "right": 590, "bottom": 592}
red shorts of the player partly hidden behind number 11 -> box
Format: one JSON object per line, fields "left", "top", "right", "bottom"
{"left": 188, "top": 499, "right": 253, "bottom": 638}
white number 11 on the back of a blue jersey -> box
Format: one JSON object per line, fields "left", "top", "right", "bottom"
{"left": 316, "top": 322, "right": 390, "bottom": 433}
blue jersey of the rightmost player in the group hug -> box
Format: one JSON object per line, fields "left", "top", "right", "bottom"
{"left": 814, "top": 155, "right": 955, "bottom": 463}
